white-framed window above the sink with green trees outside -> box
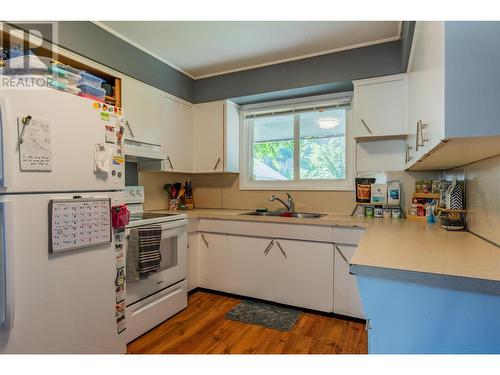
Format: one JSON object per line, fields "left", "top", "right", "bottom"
{"left": 240, "top": 94, "right": 353, "bottom": 190}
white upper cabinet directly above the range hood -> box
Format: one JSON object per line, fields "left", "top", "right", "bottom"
{"left": 122, "top": 77, "right": 161, "bottom": 145}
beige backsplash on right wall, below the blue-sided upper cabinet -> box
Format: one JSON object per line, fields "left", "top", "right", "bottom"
{"left": 453, "top": 156, "right": 500, "bottom": 246}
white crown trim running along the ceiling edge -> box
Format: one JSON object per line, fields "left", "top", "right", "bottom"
{"left": 91, "top": 21, "right": 403, "bottom": 80}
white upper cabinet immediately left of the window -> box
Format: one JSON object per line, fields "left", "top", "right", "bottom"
{"left": 193, "top": 100, "right": 239, "bottom": 173}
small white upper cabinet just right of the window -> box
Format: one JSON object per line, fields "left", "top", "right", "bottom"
{"left": 353, "top": 74, "right": 407, "bottom": 138}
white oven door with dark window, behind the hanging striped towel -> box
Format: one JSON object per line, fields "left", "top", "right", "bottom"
{"left": 126, "top": 219, "right": 187, "bottom": 306}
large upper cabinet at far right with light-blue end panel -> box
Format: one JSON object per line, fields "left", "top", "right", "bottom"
{"left": 405, "top": 21, "right": 500, "bottom": 170}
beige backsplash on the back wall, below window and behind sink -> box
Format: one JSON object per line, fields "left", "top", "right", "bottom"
{"left": 139, "top": 171, "right": 443, "bottom": 215}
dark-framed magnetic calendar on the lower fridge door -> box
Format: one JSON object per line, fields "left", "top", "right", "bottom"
{"left": 49, "top": 198, "right": 111, "bottom": 253}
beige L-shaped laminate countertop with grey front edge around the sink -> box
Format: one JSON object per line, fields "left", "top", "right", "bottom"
{"left": 151, "top": 209, "right": 500, "bottom": 293}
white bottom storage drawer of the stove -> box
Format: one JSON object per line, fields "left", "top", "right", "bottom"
{"left": 125, "top": 280, "right": 187, "bottom": 343}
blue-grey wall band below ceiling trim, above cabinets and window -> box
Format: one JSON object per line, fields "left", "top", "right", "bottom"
{"left": 11, "top": 21, "right": 415, "bottom": 103}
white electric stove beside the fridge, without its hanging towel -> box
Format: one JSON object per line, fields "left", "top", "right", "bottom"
{"left": 125, "top": 186, "right": 187, "bottom": 342}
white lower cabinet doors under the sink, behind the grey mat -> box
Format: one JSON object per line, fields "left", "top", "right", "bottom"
{"left": 200, "top": 233, "right": 334, "bottom": 312}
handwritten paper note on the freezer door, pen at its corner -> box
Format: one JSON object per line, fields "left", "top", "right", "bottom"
{"left": 17, "top": 117, "right": 52, "bottom": 171}
